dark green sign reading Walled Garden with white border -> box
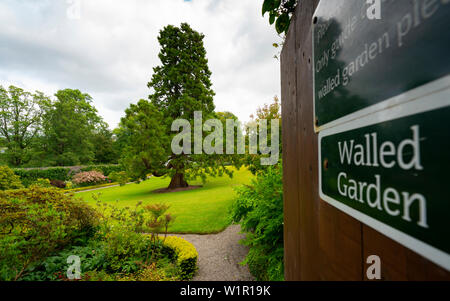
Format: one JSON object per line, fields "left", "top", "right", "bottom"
{"left": 319, "top": 87, "right": 450, "bottom": 270}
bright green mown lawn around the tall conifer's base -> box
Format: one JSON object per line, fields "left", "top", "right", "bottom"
{"left": 76, "top": 168, "right": 253, "bottom": 234}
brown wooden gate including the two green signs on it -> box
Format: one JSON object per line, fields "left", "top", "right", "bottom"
{"left": 281, "top": 0, "right": 450, "bottom": 280}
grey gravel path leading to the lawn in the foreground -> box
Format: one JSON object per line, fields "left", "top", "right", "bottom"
{"left": 176, "top": 225, "right": 254, "bottom": 281}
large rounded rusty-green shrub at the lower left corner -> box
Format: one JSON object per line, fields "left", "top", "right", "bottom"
{"left": 0, "top": 186, "right": 98, "bottom": 280}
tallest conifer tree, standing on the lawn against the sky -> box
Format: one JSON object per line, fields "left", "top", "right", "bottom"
{"left": 134, "top": 23, "right": 232, "bottom": 189}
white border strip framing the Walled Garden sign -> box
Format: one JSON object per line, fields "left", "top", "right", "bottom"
{"left": 319, "top": 77, "right": 450, "bottom": 271}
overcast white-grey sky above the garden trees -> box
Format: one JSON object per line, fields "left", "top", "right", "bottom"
{"left": 0, "top": 0, "right": 280, "bottom": 128}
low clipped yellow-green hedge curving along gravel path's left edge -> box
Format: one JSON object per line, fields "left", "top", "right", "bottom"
{"left": 160, "top": 236, "right": 198, "bottom": 280}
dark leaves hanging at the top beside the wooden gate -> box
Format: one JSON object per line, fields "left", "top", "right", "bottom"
{"left": 262, "top": 0, "right": 298, "bottom": 34}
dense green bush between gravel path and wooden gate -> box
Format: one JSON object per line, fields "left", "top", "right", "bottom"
{"left": 231, "top": 164, "right": 284, "bottom": 281}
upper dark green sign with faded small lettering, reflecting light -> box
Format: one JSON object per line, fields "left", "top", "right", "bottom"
{"left": 313, "top": 0, "right": 450, "bottom": 131}
